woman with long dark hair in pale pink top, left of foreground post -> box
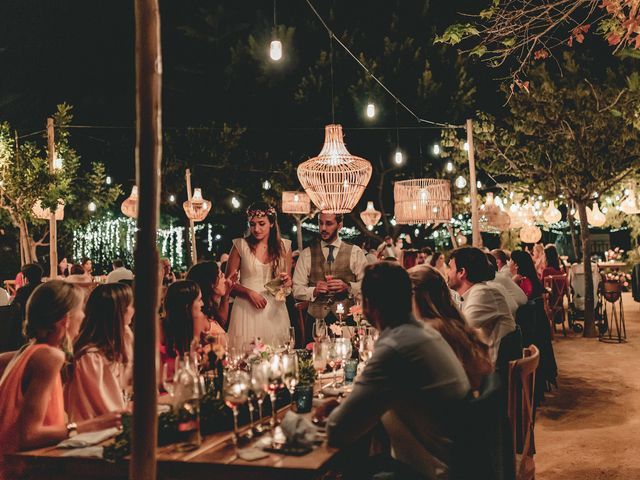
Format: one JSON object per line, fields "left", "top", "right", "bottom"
{"left": 64, "top": 283, "right": 134, "bottom": 422}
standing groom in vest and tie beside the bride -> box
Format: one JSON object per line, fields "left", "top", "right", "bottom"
{"left": 293, "top": 213, "right": 367, "bottom": 341}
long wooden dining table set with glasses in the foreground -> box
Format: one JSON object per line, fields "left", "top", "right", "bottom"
{"left": 5, "top": 410, "right": 343, "bottom": 480}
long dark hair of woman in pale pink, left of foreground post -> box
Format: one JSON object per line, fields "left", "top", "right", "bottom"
{"left": 73, "top": 283, "right": 133, "bottom": 364}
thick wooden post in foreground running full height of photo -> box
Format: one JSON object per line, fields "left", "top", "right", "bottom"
{"left": 129, "top": 0, "right": 162, "bottom": 480}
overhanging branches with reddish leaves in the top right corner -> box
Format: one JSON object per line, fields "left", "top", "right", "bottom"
{"left": 436, "top": 0, "right": 640, "bottom": 85}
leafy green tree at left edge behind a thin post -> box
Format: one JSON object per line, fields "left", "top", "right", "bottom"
{"left": 0, "top": 104, "right": 120, "bottom": 264}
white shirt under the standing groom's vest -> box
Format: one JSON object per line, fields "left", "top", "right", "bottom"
{"left": 293, "top": 237, "right": 369, "bottom": 302}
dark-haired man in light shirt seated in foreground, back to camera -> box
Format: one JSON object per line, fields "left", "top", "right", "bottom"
{"left": 327, "top": 262, "right": 470, "bottom": 478}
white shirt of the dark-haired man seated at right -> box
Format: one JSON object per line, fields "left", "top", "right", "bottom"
{"left": 462, "top": 282, "right": 516, "bottom": 364}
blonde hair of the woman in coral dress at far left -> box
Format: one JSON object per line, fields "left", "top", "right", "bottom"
{"left": 23, "top": 280, "right": 84, "bottom": 340}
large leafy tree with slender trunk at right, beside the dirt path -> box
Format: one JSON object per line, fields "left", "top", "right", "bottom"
{"left": 442, "top": 52, "right": 640, "bottom": 336}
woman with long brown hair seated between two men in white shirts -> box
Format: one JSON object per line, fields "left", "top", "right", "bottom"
{"left": 409, "top": 264, "right": 493, "bottom": 390}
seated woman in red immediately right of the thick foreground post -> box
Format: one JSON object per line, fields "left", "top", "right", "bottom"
{"left": 160, "top": 280, "right": 209, "bottom": 375}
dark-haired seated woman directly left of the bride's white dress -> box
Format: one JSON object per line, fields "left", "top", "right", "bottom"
{"left": 187, "top": 262, "right": 237, "bottom": 335}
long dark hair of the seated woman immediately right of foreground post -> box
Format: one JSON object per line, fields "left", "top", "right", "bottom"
{"left": 164, "top": 280, "right": 200, "bottom": 358}
